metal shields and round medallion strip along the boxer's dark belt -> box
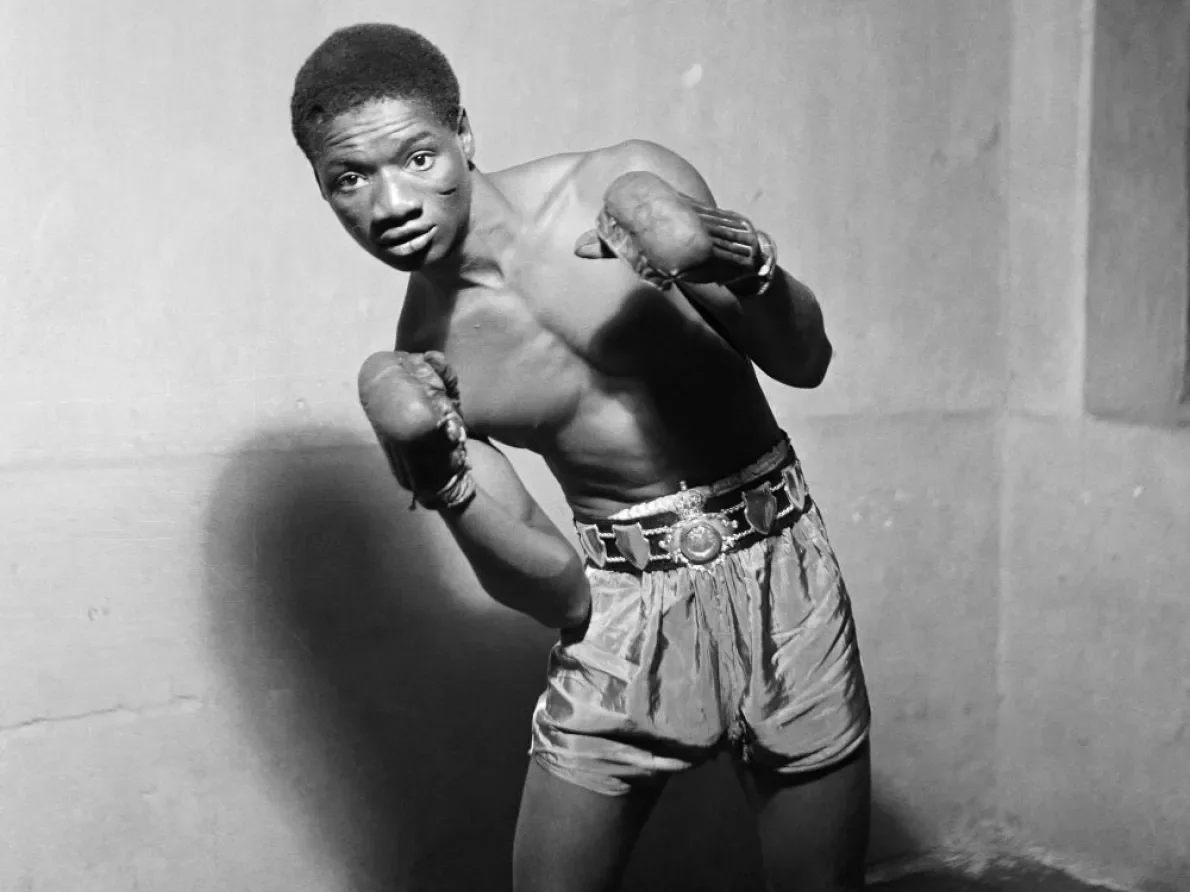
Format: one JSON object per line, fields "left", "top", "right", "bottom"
{"left": 575, "top": 464, "right": 808, "bottom": 571}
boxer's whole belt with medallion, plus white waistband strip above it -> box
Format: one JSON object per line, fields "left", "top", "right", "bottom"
{"left": 575, "top": 438, "right": 810, "bottom": 573}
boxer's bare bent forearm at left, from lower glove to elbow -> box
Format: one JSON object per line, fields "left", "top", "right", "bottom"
{"left": 440, "top": 439, "right": 590, "bottom": 629}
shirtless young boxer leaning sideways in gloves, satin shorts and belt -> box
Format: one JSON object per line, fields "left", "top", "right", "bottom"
{"left": 292, "top": 25, "right": 870, "bottom": 892}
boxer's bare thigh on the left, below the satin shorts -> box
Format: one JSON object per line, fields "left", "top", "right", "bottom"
{"left": 513, "top": 760, "right": 663, "bottom": 892}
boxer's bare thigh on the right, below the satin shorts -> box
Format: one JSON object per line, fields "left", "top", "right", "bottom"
{"left": 737, "top": 742, "right": 871, "bottom": 892}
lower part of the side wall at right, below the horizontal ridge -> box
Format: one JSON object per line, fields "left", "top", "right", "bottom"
{"left": 997, "top": 417, "right": 1190, "bottom": 892}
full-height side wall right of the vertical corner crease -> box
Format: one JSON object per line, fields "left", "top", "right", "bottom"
{"left": 995, "top": 6, "right": 1190, "bottom": 892}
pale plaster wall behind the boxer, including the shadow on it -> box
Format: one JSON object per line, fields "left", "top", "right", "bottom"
{"left": 0, "top": 0, "right": 1190, "bottom": 892}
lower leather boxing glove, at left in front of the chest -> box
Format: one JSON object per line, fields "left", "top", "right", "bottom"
{"left": 359, "top": 351, "right": 475, "bottom": 510}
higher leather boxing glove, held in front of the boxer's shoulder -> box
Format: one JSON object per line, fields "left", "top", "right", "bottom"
{"left": 575, "top": 170, "right": 777, "bottom": 297}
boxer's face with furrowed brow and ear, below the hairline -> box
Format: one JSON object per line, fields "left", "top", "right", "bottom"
{"left": 313, "top": 99, "right": 475, "bottom": 272}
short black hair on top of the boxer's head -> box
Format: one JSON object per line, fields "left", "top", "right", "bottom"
{"left": 289, "top": 24, "right": 459, "bottom": 161}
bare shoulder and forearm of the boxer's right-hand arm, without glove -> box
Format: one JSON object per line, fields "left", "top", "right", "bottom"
{"left": 580, "top": 140, "right": 833, "bottom": 388}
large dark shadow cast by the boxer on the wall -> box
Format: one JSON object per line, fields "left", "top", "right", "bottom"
{"left": 205, "top": 432, "right": 916, "bottom": 892}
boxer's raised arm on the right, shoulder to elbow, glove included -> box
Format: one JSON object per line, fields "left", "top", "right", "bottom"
{"left": 576, "top": 140, "right": 832, "bottom": 388}
